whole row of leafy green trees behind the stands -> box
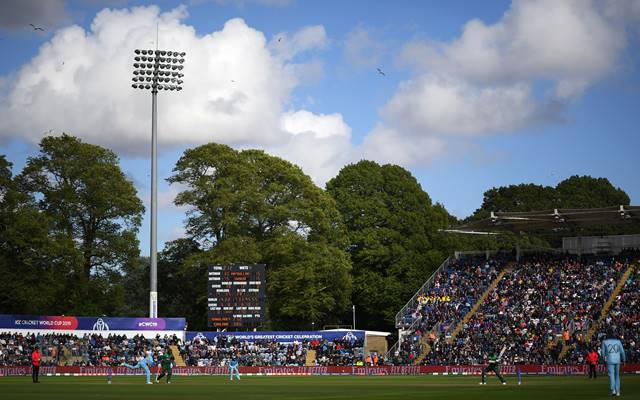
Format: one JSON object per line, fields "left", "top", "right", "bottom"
{"left": 0, "top": 135, "right": 629, "bottom": 329}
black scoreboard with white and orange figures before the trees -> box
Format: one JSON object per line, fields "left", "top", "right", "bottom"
{"left": 207, "top": 264, "right": 266, "bottom": 329}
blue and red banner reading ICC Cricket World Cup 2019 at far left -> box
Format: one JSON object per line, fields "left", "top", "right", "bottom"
{"left": 0, "top": 315, "right": 185, "bottom": 332}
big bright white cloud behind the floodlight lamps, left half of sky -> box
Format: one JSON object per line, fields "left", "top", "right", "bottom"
{"left": 0, "top": 6, "right": 350, "bottom": 184}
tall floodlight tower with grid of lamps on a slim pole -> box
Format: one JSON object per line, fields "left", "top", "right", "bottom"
{"left": 131, "top": 49, "right": 186, "bottom": 318}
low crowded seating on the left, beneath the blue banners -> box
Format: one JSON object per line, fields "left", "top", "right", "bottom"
{"left": 0, "top": 333, "right": 363, "bottom": 366}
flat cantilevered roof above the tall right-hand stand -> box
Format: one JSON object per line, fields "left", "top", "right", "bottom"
{"left": 444, "top": 205, "right": 640, "bottom": 234}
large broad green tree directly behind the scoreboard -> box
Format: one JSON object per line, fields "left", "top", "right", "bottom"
{"left": 169, "top": 143, "right": 351, "bottom": 327}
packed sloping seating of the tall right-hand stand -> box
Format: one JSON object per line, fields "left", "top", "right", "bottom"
{"left": 388, "top": 256, "right": 640, "bottom": 364}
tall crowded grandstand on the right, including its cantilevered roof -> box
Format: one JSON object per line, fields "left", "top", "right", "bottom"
{"left": 386, "top": 206, "right": 640, "bottom": 365}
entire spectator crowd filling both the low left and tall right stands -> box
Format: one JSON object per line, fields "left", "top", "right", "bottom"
{"left": 0, "top": 253, "right": 640, "bottom": 366}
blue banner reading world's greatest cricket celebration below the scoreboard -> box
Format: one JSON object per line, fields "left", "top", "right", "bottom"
{"left": 185, "top": 330, "right": 365, "bottom": 343}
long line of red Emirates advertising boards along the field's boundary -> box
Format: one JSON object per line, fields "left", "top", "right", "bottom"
{"left": 0, "top": 364, "right": 640, "bottom": 376}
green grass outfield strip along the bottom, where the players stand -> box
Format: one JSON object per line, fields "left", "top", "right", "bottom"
{"left": 0, "top": 375, "right": 640, "bottom": 400}
